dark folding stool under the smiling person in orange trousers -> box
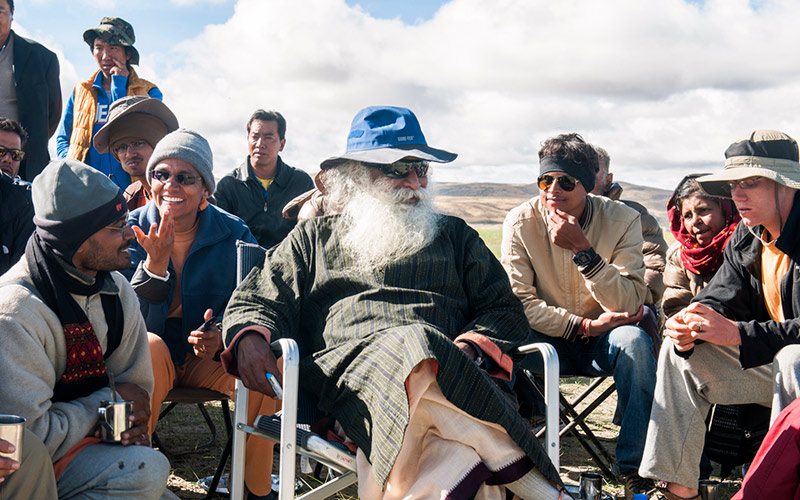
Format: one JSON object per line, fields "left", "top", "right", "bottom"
{"left": 153, "top": 387, "right": 233, "bottom": 500}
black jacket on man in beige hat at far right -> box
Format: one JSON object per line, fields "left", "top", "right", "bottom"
{"left": 693, "top": 191, "right": 800, "bottom": 368}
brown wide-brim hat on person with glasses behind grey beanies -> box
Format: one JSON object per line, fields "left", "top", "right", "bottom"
{"left": 94, "top": 96, "right": 178, "bottom": 153}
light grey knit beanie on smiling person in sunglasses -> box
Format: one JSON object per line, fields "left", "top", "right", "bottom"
{"left": 147, "top": 128, "right": 217, "bottom": 194}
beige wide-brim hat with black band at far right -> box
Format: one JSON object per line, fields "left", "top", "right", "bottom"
{"left": 697, "top": 130, "right": 800, "bottom": 198}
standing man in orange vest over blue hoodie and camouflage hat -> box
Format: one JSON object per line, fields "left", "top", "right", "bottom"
{"left": 56, "top": 17, "right": 163, "bottom": 189}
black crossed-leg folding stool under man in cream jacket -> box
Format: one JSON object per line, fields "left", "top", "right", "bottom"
{"left": 523, "top": 372, "right": 617, "bottom": 479}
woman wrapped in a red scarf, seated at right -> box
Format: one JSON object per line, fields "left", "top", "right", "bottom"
{"left": 661, "top": 174, "right": 741, "bottom": 318}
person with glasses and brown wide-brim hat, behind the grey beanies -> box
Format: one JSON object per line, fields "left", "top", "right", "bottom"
{"left": 94, "top": 96, "right": 178, "bottom": 211}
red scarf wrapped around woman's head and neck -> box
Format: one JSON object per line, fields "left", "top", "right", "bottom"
{"left": 667, "top": 176, "right": 742, "bottom": 275}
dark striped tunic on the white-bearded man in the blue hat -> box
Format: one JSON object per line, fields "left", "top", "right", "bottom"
{"left": 225, "top": 216, "right": 561, "bottom": 485}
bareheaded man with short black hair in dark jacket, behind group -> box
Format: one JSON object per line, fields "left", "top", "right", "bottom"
{"left": 214, "top": 109, "right": 314, "bottom": 248}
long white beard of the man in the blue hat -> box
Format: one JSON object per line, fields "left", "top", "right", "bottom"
{"left": 331, "top": 165, "right": 442, "bottom": 270}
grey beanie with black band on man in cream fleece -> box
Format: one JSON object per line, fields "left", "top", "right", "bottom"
{"left": 31, "top": 160, "right": 128, "bottom": 262}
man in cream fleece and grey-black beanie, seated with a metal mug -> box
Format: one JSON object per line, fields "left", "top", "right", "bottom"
{"left": 0, "top": 160, "right": 169, "bottom": 499}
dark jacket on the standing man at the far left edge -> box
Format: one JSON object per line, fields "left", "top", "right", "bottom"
{"left": 11, "top": 30, "right": 61, "bottom": 181}
